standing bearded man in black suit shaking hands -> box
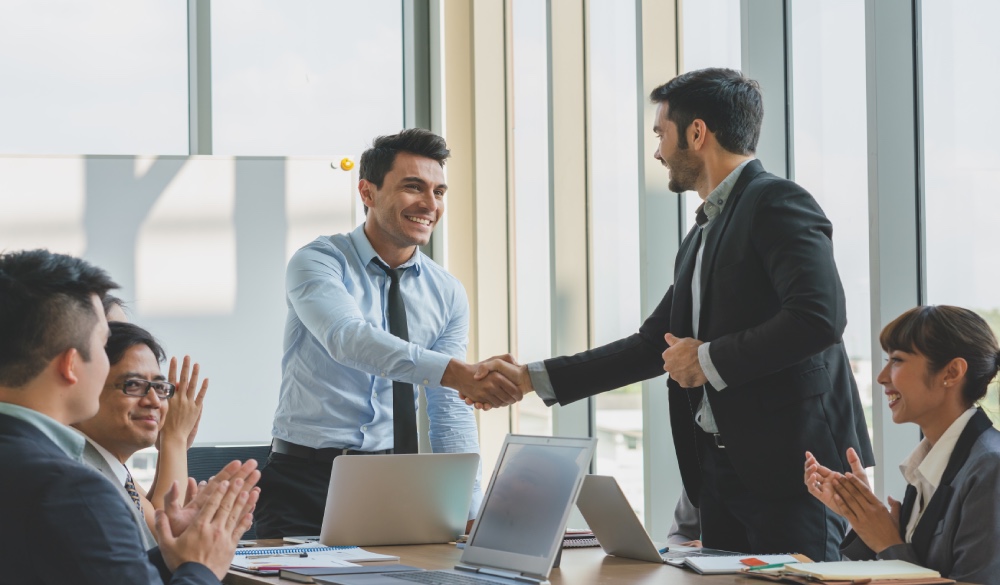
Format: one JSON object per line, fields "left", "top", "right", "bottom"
{"left": 479, "top": 69, "right": 874, "bottom": 560}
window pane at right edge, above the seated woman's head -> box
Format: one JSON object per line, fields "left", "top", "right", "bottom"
{"left": 920, "top": 0, "right": 1000, "bottom": 421}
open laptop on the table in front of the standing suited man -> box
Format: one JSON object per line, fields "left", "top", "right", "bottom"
{"left": 576, "top": 475, "right": 737, "bottom": 565}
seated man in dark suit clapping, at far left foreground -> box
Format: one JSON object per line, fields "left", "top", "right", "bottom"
{"left": 0, "top": 250, "right": 260, "bottom": 585}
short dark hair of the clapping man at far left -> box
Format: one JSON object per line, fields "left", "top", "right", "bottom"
{"left": 0, "top": 250, "right": 118, "bottom": 388}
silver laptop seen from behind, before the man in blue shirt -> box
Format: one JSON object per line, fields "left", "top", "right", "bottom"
{"left": 319, "top": 453, "right": 479, "bottom": 546}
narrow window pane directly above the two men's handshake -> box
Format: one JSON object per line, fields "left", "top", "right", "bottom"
{"left": 511, "top": 0, "right": 552, "bottom": 435}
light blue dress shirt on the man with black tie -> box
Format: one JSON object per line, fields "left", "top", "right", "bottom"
{"left": 272, "top": 224, "right": 482, "bottom": 515}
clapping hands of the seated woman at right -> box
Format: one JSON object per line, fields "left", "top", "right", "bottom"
{"left": 803, "top": 449, "right": 903, "bottom": 553}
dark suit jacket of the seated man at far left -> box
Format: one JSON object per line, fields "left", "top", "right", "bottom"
{"left": 0, "top": 414, "right": 219, "bottom": 585}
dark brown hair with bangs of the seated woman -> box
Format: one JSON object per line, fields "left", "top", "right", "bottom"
{"left": 879, "top": 305, "right": 1000, "bottom": 406}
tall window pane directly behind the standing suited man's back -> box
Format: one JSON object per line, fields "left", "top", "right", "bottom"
{"left": 792, "top": 0, "right": 872, "bottom": 432}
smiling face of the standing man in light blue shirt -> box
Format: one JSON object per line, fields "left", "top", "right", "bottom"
{"left": 358, "top": 152, "right": 448, "bottom": 265}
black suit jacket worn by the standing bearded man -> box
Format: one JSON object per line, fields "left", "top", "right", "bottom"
{"left": 545, "top": 160, "right": 874, "bottom": 504}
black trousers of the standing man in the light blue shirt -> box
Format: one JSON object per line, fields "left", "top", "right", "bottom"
{"left": 254, "top": 451, "right": 333, "bottom": 538}
